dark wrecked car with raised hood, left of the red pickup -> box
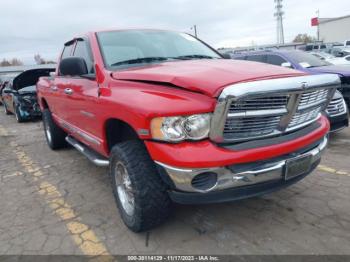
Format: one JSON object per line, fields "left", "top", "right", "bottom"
{"left": 2, "top": 68, "right": 54, "bottom": 122}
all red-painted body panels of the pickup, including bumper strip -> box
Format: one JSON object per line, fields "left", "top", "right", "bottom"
{"left": 37, "top": 30, "right": 329, "bottom": 167}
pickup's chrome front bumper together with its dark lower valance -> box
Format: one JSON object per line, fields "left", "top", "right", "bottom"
{"left": 156, "top": 137, "right": 327, "bottom": 204}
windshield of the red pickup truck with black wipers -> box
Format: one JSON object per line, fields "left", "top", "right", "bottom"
{"left": 97, "top": 30, "right": 221, "bottom": 68}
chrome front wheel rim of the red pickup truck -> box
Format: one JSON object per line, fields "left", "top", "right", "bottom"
{"left": 114, "top": 162, "right": 135, "bottom": 216}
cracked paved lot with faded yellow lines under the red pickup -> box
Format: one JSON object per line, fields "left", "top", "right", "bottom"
{"left": 0, "top": 113, "right": 350, "bottom": 255}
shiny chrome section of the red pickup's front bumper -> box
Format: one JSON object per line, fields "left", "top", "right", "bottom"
{"left": 156, "top": 137, "right": 328, "bottom": 193}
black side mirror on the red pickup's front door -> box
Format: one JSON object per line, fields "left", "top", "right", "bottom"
{"left": 59, "top": 57, "right": 88, "bottom": 76}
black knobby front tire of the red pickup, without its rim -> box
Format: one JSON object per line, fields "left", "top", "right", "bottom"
{"left": 109, "top": 140, "right": 172, "bottom": 232}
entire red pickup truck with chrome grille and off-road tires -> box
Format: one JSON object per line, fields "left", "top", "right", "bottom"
{"left": 37, "top": 29, "right": 340, "bottom": 232}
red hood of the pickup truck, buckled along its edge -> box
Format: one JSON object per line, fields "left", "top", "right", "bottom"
{"left": 112, "top": 59, "right": 305, "bottom": 97}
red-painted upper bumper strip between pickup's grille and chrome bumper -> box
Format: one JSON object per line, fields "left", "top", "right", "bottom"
{"left": 146, "top": 117, "right": 329, "bottom": 168}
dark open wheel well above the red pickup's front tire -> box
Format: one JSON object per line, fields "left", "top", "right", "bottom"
{"left": 105, "top": 119, "right": 139, "bottom": 151}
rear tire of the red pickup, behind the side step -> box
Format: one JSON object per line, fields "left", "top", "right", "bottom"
{"left": 43, "top": 109, "right": 67, "bottom": 150}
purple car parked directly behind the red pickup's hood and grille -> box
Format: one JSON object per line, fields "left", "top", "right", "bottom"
{"left": 234, "top": 50, "right": 350, "bottom": 131}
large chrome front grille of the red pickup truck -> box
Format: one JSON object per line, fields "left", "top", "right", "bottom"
{"left": 210, "top": 75, "right": 340, "bottom": 143}
